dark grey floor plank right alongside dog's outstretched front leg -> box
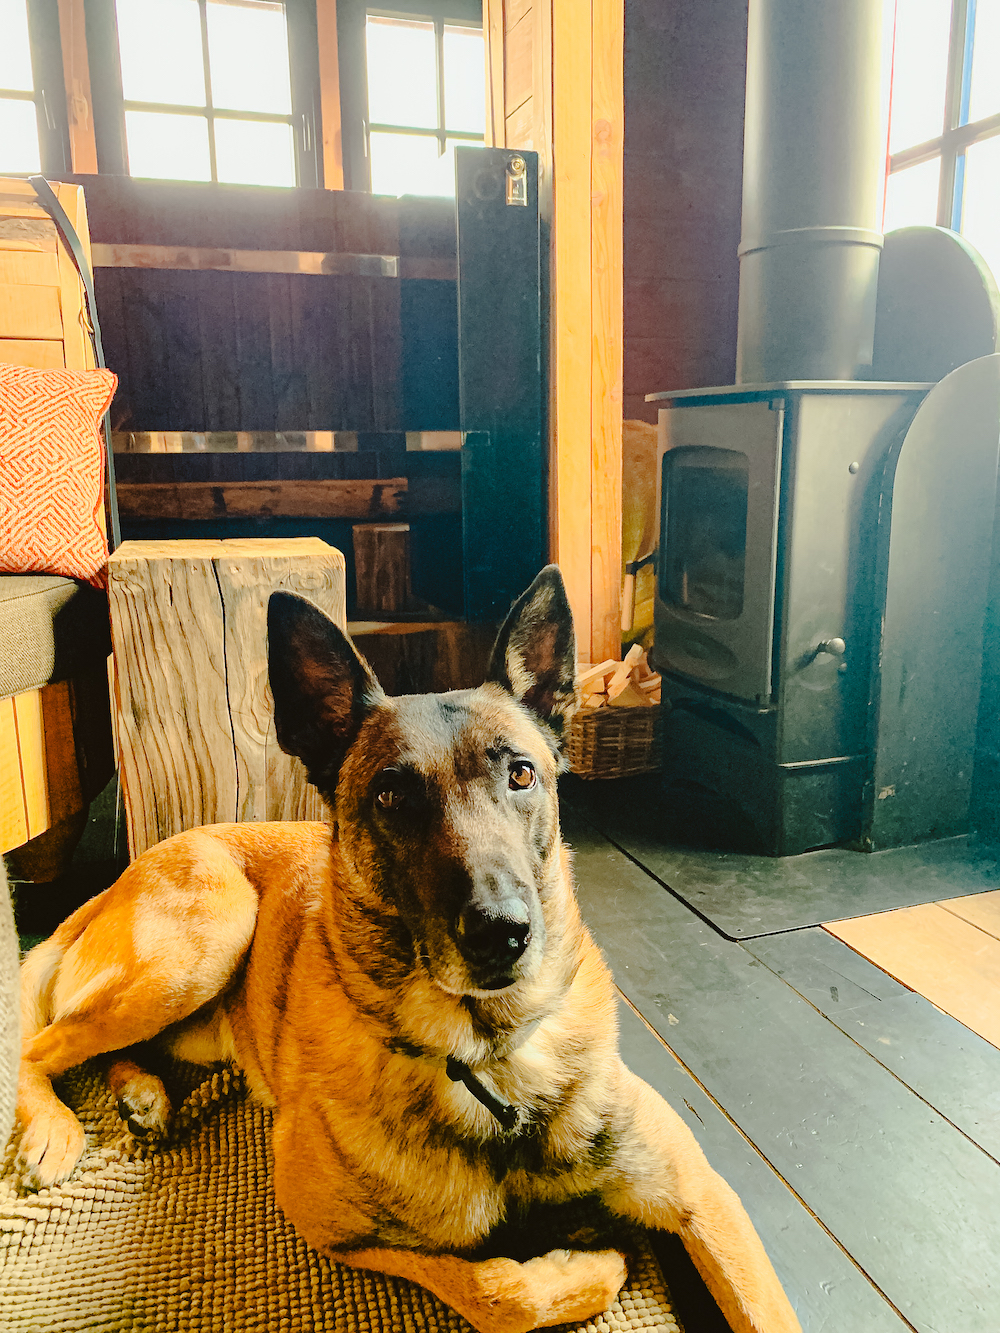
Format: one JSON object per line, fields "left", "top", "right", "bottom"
{"left": 620, "top": 1004, "right": 907, "bottom": 1333}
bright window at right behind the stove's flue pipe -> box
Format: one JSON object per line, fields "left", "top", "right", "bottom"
{"left": 884, "top": 0, "right": 1000, "bottom": 275}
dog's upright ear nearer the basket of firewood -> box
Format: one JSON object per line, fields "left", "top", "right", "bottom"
{"left": 487, "top": 565, "right": 577, "bottom": 740}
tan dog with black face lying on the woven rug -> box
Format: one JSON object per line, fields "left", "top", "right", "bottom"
{"left": 19, "top": 565, "right": 799, "bottom": 1333}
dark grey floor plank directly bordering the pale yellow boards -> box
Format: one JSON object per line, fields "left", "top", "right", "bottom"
{"left": 744, "top": 926, "right": 1000, "bottom": 1160}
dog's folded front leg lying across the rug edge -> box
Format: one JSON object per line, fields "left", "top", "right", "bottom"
{"left": 329, "top": 1249, "right": 627, "bottom": 1333}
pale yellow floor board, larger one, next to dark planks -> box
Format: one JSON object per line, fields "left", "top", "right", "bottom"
{"left": 825, "top": 902, "right": 1000, "bottom": 1048}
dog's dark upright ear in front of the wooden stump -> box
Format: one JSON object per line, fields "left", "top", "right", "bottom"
{"left": 268, "top": 592, "right": 384, "bottom": 798}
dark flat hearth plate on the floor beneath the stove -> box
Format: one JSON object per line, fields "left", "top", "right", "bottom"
{"left": 560, "top": 777, "right": 1000, "bottom": 940}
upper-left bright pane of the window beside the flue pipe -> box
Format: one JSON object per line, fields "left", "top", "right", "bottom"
{"left": 889, "top": 0, "right": 952, "bottom": 153}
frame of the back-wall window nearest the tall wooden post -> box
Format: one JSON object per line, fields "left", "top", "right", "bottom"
{"left": 337, "top": 0, "right": 485, "bottom": 193}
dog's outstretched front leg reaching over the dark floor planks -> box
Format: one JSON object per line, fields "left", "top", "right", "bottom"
{"left": 603, "top": 1065, "right": 801, "bottom": 1333}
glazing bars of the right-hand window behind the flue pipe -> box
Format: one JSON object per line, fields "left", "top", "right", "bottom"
{"left": 887, "top": 0, "right": 1000, "bottom": 232}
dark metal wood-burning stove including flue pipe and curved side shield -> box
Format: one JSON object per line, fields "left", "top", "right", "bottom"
{"left": 648, "top": 0, "right": 1000, "bottom": 856}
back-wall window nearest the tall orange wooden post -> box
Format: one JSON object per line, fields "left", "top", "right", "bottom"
{"left": 337, "top": 0, "right": 485, "bottom": 197}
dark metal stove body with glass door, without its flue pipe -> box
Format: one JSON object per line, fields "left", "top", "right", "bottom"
{"left": 653, "top": 381, "right": 929, "bottom": 856}
